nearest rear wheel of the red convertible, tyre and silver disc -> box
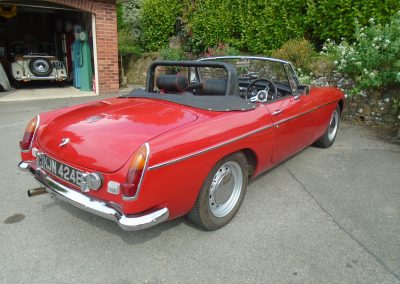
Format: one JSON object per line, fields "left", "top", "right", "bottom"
{"left": 188, "top": 153, "right": 248, "bottom": 230}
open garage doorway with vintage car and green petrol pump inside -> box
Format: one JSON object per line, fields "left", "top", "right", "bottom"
{"left": 0, "top": 0, "right": 98, "bottom": 96}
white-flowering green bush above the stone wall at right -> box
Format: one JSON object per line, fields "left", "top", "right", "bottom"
{"left": 321, "top": 11, "right": 400, "bottom": 94}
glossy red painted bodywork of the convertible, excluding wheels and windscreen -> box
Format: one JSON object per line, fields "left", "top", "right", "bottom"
{"left": 20, "top": 57, "right": 344, "bottom": 230}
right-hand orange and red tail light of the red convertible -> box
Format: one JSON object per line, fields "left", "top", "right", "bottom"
{"left": 121, "top": 143, "right": 150, "bottom": 200}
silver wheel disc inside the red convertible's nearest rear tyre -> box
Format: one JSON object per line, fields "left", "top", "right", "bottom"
{"left": 208, "top": 161, "right": 243, "bottom": 218}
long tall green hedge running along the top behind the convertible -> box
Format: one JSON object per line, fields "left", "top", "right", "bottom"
{"left": 121, "top": 0, "right": 400, "bottom": 53}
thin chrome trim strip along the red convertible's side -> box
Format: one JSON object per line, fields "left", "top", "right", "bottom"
{"left": 148, "top": 101, "right": 337, "bottom": 171}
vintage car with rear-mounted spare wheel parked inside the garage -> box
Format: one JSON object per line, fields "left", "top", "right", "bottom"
{"left": 11, "top": 53, "right": 67, "bottom": 87}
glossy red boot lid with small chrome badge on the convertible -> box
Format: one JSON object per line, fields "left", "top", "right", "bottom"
{"left": 38, "top": 98, "right": 197, "bottom": 172}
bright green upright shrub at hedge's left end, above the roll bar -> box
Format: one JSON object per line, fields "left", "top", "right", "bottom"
{"left": 140, "top": 0, "right": 182, "bottom": 51}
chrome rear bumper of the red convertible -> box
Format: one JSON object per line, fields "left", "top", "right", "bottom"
{"left": 18, "top": 162, "right": 169, "bottom": 231}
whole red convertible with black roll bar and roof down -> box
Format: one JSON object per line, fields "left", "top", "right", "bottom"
{"left": 19, "top": 56, "right": 344, "bottom": 230}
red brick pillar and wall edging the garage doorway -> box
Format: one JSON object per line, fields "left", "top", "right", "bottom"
{"left": 48, "top": 0, "right": 119, "bottom": 94}
